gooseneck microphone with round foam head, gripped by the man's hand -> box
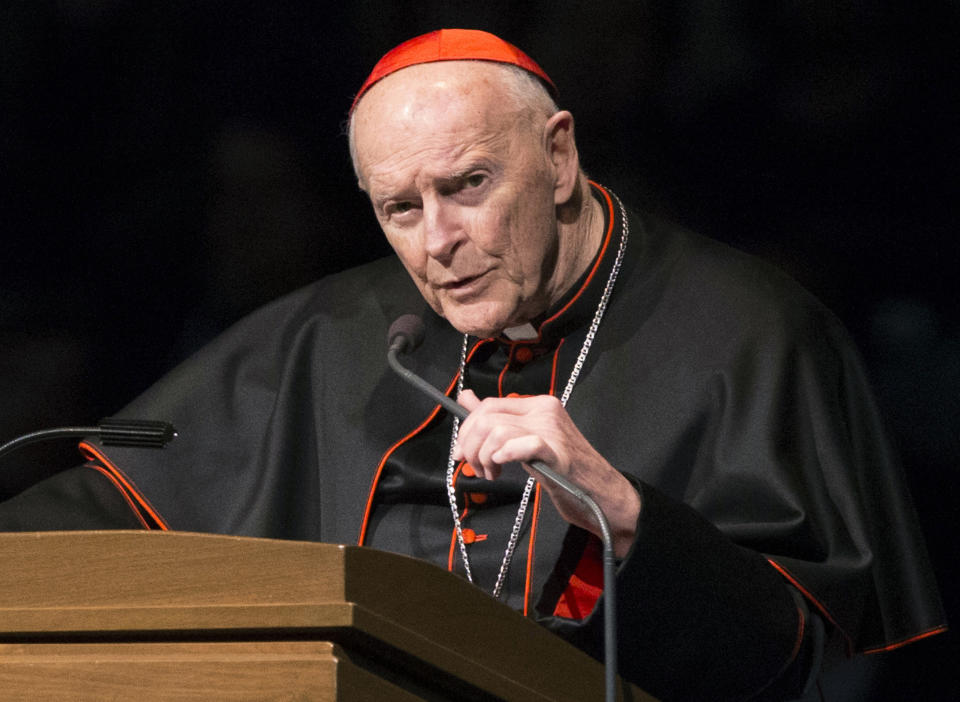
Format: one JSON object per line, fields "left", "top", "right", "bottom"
{"left": 387, "top": 314, "right": 617, "bottom": 702}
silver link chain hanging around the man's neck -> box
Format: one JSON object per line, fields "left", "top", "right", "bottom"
{"left": 446, "top": 191, "right": 630, "bottom": 599}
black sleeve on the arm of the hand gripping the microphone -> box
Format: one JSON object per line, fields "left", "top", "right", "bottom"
{"left": 542, "top": 485, "right": 823, "bottom": 702}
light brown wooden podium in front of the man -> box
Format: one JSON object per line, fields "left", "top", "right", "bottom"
{"left": 0, "top": 531, "right": 653, "bottom": 702}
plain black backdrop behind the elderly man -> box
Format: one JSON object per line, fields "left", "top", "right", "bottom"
{"left": 0, "top": 0, "right": 960, "bottom": 700}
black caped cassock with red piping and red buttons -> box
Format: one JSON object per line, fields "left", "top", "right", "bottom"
{"left": 0, "top": 187, "right": 944, "bottom": 700}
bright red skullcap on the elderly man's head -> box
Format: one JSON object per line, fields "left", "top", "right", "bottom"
{"left": 350, "top": 29, "right": 557, "bottom": 113}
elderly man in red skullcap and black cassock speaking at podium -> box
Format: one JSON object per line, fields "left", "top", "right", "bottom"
{"left": 0, "top": 30, "right": 943, "bottom": 700}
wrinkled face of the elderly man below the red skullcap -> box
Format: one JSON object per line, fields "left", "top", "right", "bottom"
{"left": 354, "top": 62, "right": 558, "bottom": 336}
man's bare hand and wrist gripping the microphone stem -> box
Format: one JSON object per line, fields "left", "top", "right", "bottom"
{"left": 453, "top": 390, "right": 640, "bottom": 558}
